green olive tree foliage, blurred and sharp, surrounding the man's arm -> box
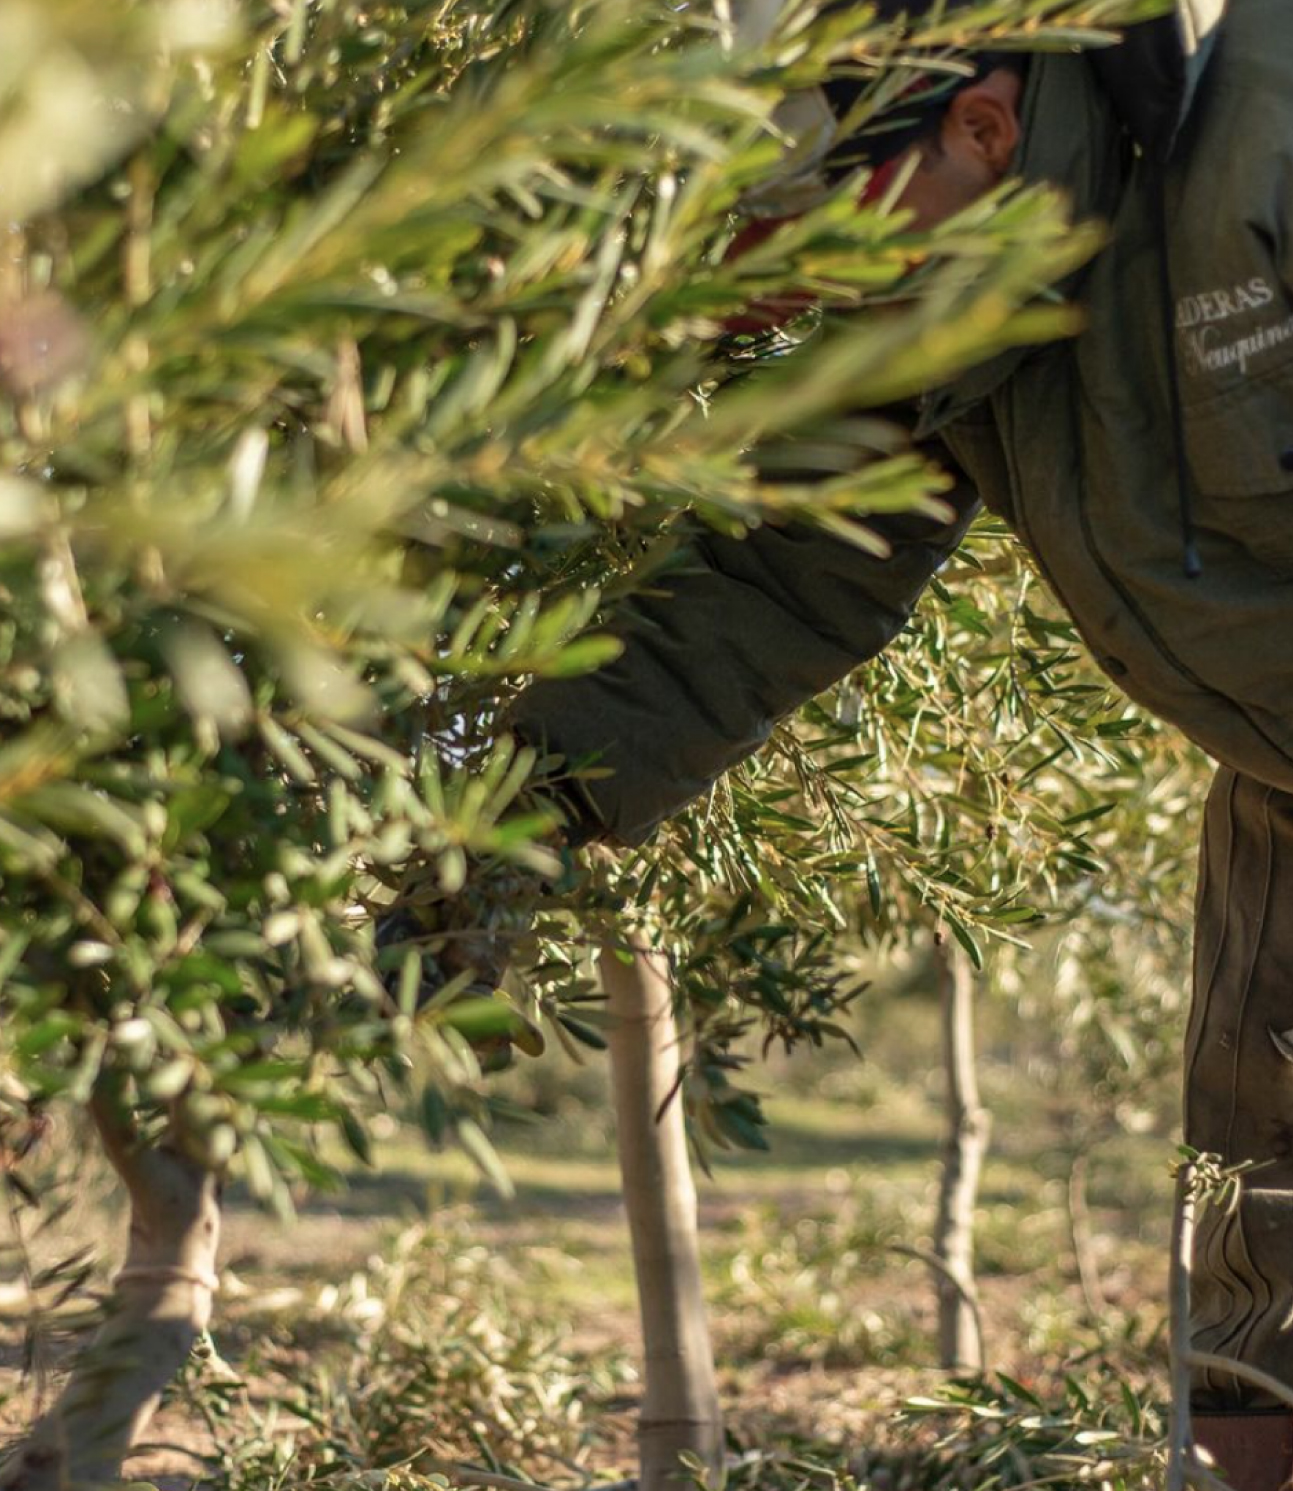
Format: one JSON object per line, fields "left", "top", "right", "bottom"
{"left": 0, "top": 0, "right": 1202, "bottom": 1206}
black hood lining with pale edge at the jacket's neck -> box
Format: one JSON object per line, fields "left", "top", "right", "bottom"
{"left": 1089, "top": 0, "right": 1227, "bottom": 160}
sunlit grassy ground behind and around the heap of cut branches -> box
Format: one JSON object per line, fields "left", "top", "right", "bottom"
{"left": 0, "top": 1043, "right": 1171, "bottom": 1488}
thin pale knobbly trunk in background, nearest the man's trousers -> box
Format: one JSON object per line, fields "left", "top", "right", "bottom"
{"left": 934, "top": 942, "right": 992, "bottom": 1372}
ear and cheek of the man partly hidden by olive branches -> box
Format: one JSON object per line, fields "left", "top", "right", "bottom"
{"left": 898, "top": 67, "right": 1023, "bottom": 228}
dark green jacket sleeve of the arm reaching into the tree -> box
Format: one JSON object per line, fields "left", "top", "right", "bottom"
{"left": 510, "top": 459, "right": 977, "bottom": 844}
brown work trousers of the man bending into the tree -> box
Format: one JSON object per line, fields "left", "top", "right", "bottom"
{"left": 1186, "top": 768, "right": 1293, "bottom": 1409}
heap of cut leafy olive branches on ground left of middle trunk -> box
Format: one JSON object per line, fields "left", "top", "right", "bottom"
{"left": 172, "top": 1214, "right": 632, "bottom": 1491}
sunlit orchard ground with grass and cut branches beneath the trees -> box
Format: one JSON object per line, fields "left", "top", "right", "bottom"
{"left": 0, "top": 972, "right": 1175, "bottom": 1491}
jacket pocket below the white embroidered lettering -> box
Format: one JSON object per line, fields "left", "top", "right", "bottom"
{"left": 1184, "top": 359, "right": 1293, "bottom": 579}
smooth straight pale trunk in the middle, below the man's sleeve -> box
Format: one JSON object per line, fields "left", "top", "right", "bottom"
{"left": 601, "top": 944, "right": 723, "bottom": 1491}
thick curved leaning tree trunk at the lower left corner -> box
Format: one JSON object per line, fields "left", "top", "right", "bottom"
{"left": 0, "top": 1102, "right": 219, "bottom": 1491}
